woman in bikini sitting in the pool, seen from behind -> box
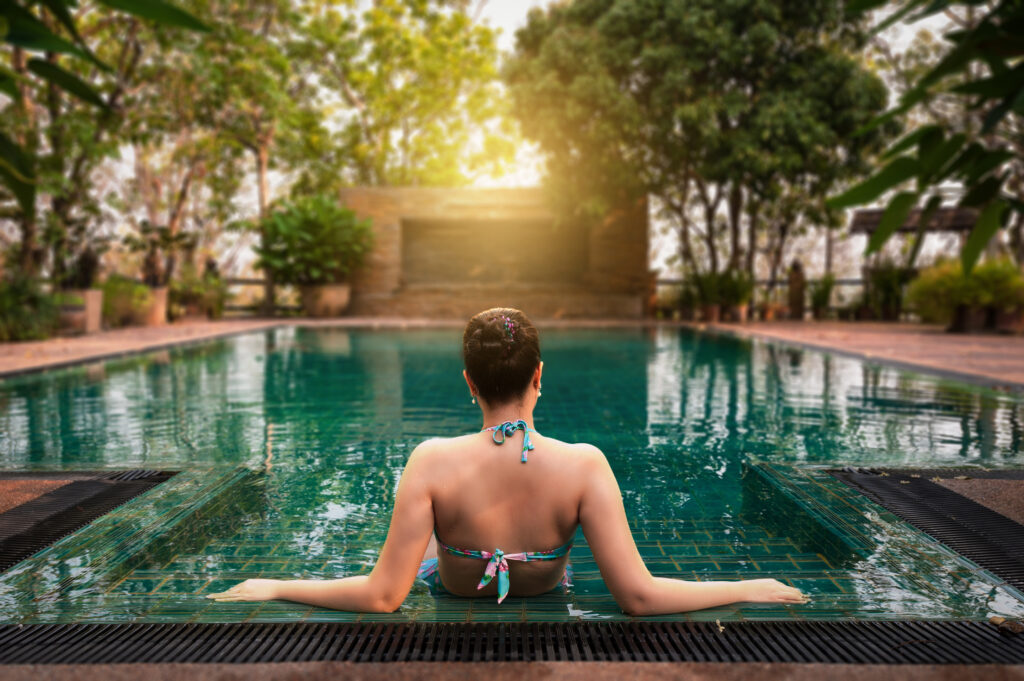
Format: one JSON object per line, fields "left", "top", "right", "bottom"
{"left": 209, "top": 308, "right": 806, "bottom": 615}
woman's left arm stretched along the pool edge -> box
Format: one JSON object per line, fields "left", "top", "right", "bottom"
{"left": 208, "top": 443, "right": 434, "bottom": 612}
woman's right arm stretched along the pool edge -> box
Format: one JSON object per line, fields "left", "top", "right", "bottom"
{"left": 580, "top": 449, "right": 807, "bottom": 615}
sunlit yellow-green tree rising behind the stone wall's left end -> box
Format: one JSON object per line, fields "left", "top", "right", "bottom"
{"left": 295, "top": 0, "right": 513, "bottom": 189}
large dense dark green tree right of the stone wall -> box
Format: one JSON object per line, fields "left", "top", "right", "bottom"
{"left": 505, "top": 0, "right": 889, "bottom": 288}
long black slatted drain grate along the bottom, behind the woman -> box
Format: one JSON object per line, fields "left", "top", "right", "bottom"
{"left": 0, "top": 622, "right": 1024, "bottom": 665}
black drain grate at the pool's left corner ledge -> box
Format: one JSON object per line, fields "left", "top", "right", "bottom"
{"left": 0, "top": 470, "right": 174, "bottom": 571}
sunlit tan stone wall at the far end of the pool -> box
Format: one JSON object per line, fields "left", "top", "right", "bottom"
{"left": 341, "top": 187, "right": 649, "bottom": 318}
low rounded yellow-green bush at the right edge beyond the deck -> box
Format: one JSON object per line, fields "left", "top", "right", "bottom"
{"left": 906, "top": 259, "right": 1024, "bottom": 325}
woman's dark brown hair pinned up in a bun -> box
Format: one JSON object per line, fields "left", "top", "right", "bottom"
{"left": 462, "top": 307, "right": 541, "bottom": 405}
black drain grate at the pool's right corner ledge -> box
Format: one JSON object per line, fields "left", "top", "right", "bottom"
{"left": 828, "top": 468, "right": 1024, "bottom": 591}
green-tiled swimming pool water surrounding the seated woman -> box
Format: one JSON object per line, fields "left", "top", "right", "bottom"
{"left": 0, "top": 327, "right": 1024, "bottom": 623}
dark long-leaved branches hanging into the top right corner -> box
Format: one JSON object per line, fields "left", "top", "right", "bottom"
{"left": 829, "top": 0, "right": 1024, "bottom": 272}
